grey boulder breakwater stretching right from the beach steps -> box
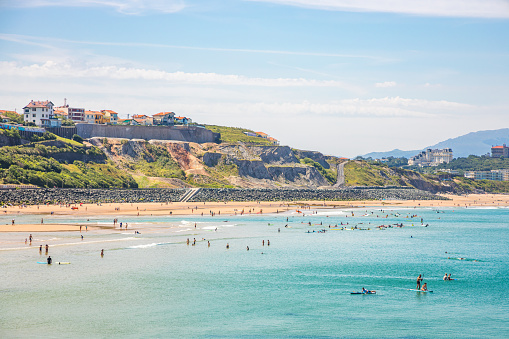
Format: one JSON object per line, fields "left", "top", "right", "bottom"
{"left": 190, "top": 187, "right": 447, "bottom": 202}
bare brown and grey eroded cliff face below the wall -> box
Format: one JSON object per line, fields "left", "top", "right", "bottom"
{"left": 90, "top": 138, "right": 336, "bottom": 188}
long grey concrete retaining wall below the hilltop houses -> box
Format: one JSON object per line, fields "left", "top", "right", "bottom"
{"left": 76, "top": 124, "right": 220, "bottom": 143}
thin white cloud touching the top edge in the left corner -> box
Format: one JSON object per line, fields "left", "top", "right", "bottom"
{"left": 0, "top": 0, "right": 186, "bottom": 14}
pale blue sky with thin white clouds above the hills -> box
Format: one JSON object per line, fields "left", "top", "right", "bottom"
{"left": 0, "top": 0, "right": 509, "bottom": 157}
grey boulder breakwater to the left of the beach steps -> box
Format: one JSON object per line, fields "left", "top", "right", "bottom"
{"left": 0, "top": 188, "right": 187, "bottom": 205}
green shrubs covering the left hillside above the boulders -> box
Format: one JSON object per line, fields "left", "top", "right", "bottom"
{"left": 0, "top": 145, "right": 137, "bottom": 188}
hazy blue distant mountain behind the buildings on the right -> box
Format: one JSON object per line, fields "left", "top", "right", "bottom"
{"left": 362, "top": 128, "right": 509, "bottom": 159}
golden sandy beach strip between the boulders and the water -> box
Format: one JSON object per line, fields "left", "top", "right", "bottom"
{"left": 0, "top": 194, "right": 509, "bottom": 232}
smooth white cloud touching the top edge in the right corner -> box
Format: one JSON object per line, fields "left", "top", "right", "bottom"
{"left": 247, "top": 0, "right": 509, "bottom": 18}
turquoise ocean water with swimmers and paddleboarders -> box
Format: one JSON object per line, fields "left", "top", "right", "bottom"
{"left": 0, "top": 208, "right": 509, "bottom": 338}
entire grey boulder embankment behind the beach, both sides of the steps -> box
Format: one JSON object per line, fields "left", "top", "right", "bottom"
{"left": 0, "top": 188, "right": 446, "bottom": 205}
